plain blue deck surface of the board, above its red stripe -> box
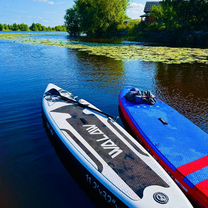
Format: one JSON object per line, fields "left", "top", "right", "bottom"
{"left": 120, "top": 89, "right": 208, "bottom": 169}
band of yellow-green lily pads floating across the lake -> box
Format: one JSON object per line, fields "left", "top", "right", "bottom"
{"left": 0, "top": 35, "right": 208, "bottom": 64}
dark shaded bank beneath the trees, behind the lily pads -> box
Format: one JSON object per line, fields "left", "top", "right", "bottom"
{"left": 81, "top": 31, "right": 208, "bottom": 48}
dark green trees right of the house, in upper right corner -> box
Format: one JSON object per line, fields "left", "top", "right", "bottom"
{"left": 141, "top": 0, "right": 208, "bottom": 31}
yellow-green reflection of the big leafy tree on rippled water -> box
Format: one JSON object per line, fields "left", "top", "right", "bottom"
{"left": 70, "top": 51, "right": 125, "bottom": 86}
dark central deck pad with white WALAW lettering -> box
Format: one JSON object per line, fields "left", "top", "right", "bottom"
{"left": 52, "top": 104, "right": 169, "bottom": 198}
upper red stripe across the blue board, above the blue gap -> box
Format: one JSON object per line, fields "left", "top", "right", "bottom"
{"left": 178, "top": 156, "right": 208, "bottom": 176}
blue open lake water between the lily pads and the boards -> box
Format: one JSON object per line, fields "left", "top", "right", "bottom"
{"left": 0, "top": 33, "right": 208, "bottom": 208}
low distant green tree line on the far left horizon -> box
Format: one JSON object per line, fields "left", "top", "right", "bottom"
{"left": 0, "top": 23, "right": 66, "bottom": 32}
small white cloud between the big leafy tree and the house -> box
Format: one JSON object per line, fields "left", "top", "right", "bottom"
{"left": 127, "top": 2, "right": 144, "bottom": 19}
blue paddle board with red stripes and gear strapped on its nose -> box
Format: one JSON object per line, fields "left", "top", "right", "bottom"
{"left": 119, "top": 88, "right": 208, "bottom": 208}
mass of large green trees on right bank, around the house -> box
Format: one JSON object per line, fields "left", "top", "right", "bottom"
{"left": 65, "top": 0, "right": 208, "bottom": 37}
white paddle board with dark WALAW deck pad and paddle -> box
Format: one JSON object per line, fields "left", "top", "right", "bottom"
{"left": 42, "top": 84, "right": 192, "bottom": 208}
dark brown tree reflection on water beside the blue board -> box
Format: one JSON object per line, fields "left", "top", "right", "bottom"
{"left": 156, "top": 64, "right": 208, "bottom": 132}
